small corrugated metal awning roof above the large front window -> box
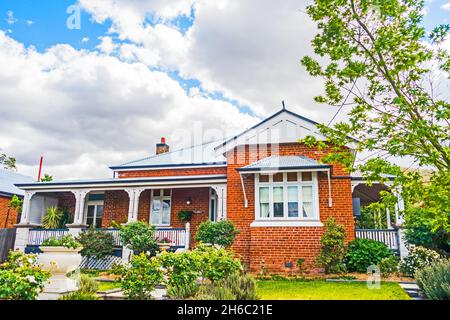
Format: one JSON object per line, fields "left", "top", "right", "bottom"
{"left": 238, "top": 156, "right": 330, "bottom": 172}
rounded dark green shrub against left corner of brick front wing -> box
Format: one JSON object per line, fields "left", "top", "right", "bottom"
{"left": 195, "top": 220, "right": 239, "bottom": 247}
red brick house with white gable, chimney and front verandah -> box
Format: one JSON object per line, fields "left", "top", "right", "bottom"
{"left": 16, "top": 108, "right": 408, "bottom": 272}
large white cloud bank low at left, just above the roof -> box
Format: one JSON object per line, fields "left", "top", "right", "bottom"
{"left": 0, "top": 32, "right": 257, "bottom": 178}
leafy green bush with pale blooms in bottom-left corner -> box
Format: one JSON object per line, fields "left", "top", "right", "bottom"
{"left": 0, "top": 251, "right": 50, "bottom": 300}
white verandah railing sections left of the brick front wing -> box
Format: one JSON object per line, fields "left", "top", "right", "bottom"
{"left": 28, "top": 228, "right": 187, "bottom": 248}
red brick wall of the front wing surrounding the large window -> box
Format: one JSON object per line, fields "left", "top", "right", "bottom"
{"left": 227, "top": 143, "right": 354, "bottom": 273}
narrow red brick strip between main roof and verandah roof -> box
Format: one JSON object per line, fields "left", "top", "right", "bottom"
{"left": 118, "top": 167, "right": 227, "bottom": 178}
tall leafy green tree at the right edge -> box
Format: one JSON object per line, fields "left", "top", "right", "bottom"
{"left": 302, "top": 0, "right": 450, "bottom": 250}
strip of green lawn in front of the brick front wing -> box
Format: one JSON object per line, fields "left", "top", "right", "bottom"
{"left": 258, "top": 280, "right": 410, "bottom": 300}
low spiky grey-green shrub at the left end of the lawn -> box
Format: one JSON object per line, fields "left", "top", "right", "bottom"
{"left": 196, "top": 274, "right": 259, "bottom": 301}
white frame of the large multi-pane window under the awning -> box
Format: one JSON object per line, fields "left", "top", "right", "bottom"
{"left": 255, "top": 170, "right": 322, "bottom": 226}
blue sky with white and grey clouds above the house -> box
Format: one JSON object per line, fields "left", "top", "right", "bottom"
{"left": 0, "top": 0, "right": 450, "bottom": 179}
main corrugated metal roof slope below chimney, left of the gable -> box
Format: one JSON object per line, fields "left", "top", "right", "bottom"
{"left": 111, "top": 140, "right": 226, "bottom": 170}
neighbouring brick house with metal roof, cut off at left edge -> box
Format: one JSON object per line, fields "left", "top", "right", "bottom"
{"left": 0, "top": 169, "right": 33, "bottom": 229}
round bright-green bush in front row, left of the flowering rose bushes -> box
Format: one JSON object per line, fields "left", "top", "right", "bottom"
{"left": 116, "top": 253, "right": 163, "bottom": 300}
